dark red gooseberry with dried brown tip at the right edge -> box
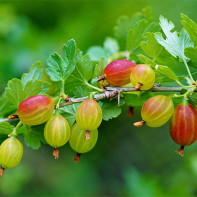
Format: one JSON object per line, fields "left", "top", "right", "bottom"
{"left": 170, "top": 101, "right": 197, "bottom": 156}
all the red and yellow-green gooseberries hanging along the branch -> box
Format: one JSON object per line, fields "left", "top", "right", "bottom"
{"left": 0, "top": 56, "right": 197, "bottom": 176}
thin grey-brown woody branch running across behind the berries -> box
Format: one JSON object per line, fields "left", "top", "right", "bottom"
{"left": 0, "top": 87, "right": 197, "bottom": 122}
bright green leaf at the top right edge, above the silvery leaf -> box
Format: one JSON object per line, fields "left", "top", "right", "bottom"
{"left": 181, "top": 14, "right": 197, "bottom": 45}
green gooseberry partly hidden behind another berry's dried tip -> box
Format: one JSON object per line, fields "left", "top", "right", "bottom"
{"left": 69, "top": 123, "right": 98, "bottom": 153}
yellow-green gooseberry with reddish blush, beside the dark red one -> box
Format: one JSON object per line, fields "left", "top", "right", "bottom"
{"left": 141, "top": 95, "right": 174, "bottom": 127}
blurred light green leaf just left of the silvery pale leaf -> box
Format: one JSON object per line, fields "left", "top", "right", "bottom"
{"left": 127, "top": 20, "right": 158, "bottom": 51}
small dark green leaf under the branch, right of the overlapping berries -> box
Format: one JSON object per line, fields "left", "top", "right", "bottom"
{"left": 99, "top": 100, "right": 122, "bottom": 121}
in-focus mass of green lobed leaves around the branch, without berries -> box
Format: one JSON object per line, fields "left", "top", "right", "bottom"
{"left": 0, "top": 8, "right": 197, "bottom": 157}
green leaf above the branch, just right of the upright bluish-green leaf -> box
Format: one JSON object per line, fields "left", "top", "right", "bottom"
{"left": 65, "top": 55, "right": 94, "bottom": 96}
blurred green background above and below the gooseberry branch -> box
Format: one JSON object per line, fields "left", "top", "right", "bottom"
{"left": 0, "top": 0, "right": 197, "bottom": 197}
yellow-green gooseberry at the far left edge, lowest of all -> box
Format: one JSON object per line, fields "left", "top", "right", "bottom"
{"left": 0, "top": 136, "right": 23, "bottom": 169}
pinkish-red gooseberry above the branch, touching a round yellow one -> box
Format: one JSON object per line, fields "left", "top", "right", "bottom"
{"left": 104, "top": 59, "right": 136, "bottom": 86}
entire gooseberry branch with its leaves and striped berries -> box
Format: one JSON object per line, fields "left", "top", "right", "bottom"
{"left": 0, "top": 8, "right": 197, "bottom": 176}
